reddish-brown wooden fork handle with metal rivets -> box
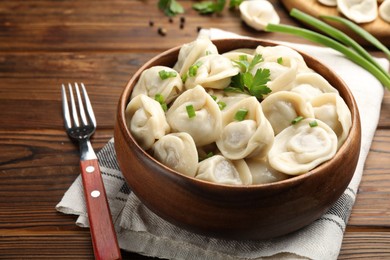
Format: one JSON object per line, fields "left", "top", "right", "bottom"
{"left": 80, "top": 159, "right": 122, "bottom": 260}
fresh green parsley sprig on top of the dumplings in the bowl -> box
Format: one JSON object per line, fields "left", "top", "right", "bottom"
{"left": 225, "top": 54, "right": 271, "bottom": 99}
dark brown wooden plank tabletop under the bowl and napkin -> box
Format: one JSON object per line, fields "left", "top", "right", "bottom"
{"left": 0, "top": 0, "right": 390, "bottom": 259}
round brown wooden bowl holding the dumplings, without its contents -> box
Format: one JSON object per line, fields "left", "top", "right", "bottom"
{"left": 114, "top": 39, "right": 361, "bottom": 239}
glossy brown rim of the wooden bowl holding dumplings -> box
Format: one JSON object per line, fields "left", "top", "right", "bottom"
{"left": 117, "top": 38, "right": 361, "bottom": 191}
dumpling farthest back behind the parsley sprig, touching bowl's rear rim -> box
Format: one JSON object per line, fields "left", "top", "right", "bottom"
{"left": 255, "top": 45, "right": 312, "bottom": 72}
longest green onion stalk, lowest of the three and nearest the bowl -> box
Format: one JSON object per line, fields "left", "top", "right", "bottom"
{"left": 265, "top": 24, "right": 390, "bottom": 89}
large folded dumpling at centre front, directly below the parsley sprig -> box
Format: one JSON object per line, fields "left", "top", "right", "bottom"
{"left": 216, "top": 96, "right": 274, "bottom": 160}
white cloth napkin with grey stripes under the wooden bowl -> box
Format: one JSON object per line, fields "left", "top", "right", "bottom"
{"left": 56, "top": 29, "right": 389, "bottom": 260}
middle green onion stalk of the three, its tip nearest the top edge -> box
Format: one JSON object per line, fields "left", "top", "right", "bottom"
{"left": 290, "top": 8, "right": 390, "bottom": 82}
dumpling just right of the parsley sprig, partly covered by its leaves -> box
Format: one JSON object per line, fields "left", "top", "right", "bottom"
{"left": 251, "top": 54, "right": 298, "bottom": 93}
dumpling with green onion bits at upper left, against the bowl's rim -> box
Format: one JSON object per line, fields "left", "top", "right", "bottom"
{"left": 131, "top": 66, "right": 183, "bottom": 103}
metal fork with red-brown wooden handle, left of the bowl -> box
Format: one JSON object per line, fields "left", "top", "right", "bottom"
{"left": 62, "top": 83, "right": 121, "bottom": 259}
